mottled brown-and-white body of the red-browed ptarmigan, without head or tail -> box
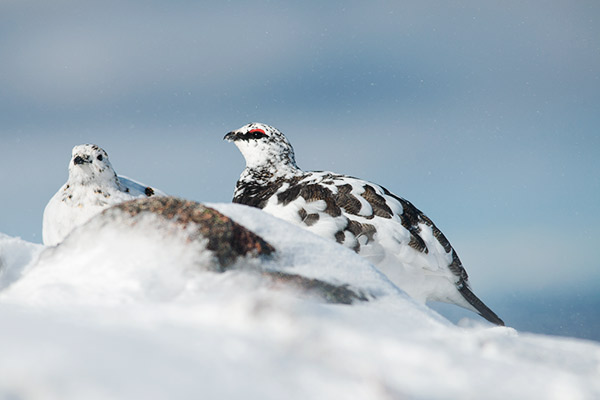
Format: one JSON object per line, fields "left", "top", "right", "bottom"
{"left": 234, "top": 172, "right": 467, "bottom": 303}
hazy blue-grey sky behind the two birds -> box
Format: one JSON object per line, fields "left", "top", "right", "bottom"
{"left": 0, "top": 0, "right": 600, "bottom": 337}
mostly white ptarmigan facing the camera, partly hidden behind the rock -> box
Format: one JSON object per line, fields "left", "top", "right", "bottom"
{"left": 42, "top": 144, "right": 165, "bottom": 246}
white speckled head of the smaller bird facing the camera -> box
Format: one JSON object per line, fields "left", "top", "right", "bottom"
{"left": 69, "top": 144, "right": 117, "bottom": 184}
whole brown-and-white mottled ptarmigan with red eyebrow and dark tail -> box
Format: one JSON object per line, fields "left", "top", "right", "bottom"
{"left": 224, "top": 123, "right": 504, "bottom": 325}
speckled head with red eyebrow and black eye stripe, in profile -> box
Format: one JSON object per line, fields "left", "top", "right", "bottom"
{"left": 223, "top": 122, "right": 298, "bottom": 170}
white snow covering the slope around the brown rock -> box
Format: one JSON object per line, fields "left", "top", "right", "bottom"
{"left": 0, "top": 204, "right": 600, "bottom": 400}
